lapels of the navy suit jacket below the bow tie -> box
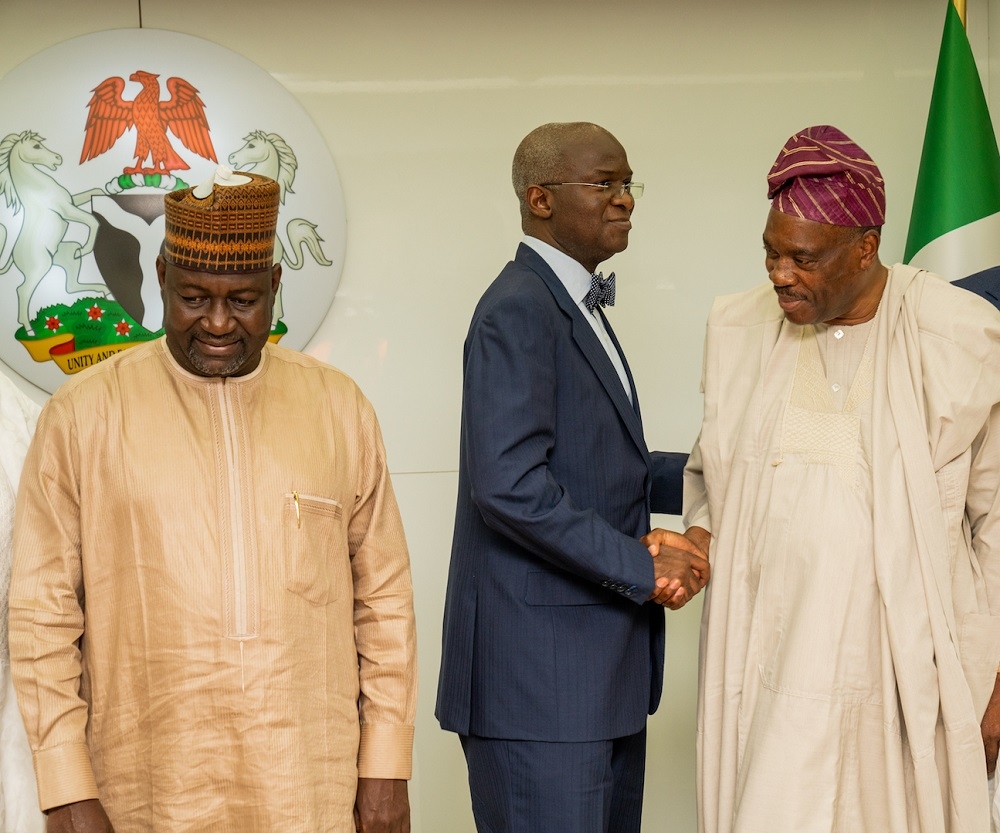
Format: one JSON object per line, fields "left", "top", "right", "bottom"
{"left": 515, "top": 243, "right": 649, "bottom": 458}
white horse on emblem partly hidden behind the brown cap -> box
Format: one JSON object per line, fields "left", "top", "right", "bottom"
{"left": 229, "top": 130, "right": 333, "bottom": 329}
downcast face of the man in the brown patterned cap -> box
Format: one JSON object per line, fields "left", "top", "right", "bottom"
{"left": 156, "top": 256, "right": 281, "bottom": 376}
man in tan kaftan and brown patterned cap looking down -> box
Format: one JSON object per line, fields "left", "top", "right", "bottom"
{"left": 10, "top": 169, "right": 415, "bottom": 833}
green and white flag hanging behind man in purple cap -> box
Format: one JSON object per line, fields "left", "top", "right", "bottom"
{"left": 903, "top": 0, "right": 1000, "bottom": 306}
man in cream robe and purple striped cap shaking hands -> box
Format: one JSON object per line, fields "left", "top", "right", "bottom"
{"left": 685, "top": 127, "right": 1000, "bottom": 833}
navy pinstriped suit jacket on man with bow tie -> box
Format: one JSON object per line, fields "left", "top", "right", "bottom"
{"left": 436, "top": 244, "right": 686, "bottom": 741}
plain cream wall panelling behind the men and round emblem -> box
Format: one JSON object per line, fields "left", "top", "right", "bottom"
{"left": 0, "top": 0, "right": 1000, "bottom": 833}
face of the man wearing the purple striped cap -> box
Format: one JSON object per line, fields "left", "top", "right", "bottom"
{"left": 764, "top": 209, "right": 886, "bottom": 325}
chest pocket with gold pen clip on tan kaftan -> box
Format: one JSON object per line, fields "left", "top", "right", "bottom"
{"left": 282, "top": 492, "right": 349, "bottom": 605}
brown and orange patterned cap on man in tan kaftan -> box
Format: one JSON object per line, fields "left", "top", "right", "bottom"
{"left": 163, "top": 165, "right": 280, "bottom": 273}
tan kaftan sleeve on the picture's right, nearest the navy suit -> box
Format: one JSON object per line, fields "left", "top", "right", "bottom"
{"left": 348, "top": 394, "right": 417, "bottom": 778}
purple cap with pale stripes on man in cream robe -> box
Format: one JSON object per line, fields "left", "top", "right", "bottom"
{"left": 767, "top": 124, "right": 885, "bottom": 228}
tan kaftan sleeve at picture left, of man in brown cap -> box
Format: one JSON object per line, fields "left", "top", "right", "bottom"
{"left": 10, "top": 399, "right": 98, "bottom": 809}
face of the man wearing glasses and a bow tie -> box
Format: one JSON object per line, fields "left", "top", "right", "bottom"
{"left": 525, "top": 128, "right": 635, "bottom": 272}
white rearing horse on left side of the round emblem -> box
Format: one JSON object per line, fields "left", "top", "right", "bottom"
{"left": 0, "top": 130, "right": 109, "bottom": 335}
